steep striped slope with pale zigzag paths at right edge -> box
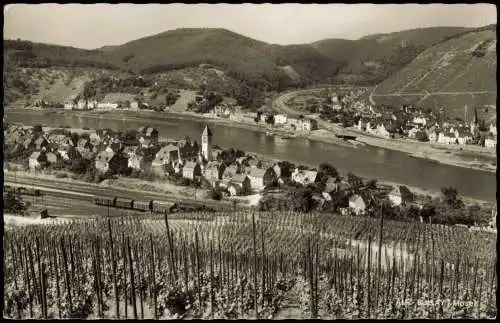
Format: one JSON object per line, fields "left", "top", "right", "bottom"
{"left": 372, "top": 26, "right": 497, "bottom": 120}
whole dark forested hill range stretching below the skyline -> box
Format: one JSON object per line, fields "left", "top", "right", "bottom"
{"left": 4, "top": 27, "right": 496, "bottom": 96}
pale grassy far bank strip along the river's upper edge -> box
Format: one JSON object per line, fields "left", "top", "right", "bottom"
{"left": 13, "top": 109, "right": 496, "bottom": 173}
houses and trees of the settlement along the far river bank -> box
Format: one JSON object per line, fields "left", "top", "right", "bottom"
{"left": 33, "top": 83, "right": 497, "bottom": 149}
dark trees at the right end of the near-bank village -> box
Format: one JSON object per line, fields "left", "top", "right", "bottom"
{"left": 259, "top": 163, "right": 491, "bottom": 226}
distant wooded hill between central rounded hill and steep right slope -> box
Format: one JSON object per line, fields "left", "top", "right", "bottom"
{"left": 311, "top": 27, "right": 471, "bottom": 85}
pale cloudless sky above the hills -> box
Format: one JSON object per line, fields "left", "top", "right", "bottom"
{"left": 4, "top": 4, "right": 497, "bottom": 49}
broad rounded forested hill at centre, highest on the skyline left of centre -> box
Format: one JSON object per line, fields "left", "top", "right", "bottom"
{"left": 93, "top": 28, "right": 341, "bottom": 90}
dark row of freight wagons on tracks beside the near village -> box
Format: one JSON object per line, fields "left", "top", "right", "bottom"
{"left": 93, "top": 196, "right": 215, "bottom": 214}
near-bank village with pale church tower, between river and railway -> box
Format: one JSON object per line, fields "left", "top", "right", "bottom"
{"left": 4, "top": 124, "right": 493, "bottom": 229}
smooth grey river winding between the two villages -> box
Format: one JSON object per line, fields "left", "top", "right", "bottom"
{"left": 6, "top": 111, "right": 496, "bottom": 202}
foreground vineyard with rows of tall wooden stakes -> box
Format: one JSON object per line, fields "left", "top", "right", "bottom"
{"left": 3, "top": 212, "right": 497, "bottom": 319}
